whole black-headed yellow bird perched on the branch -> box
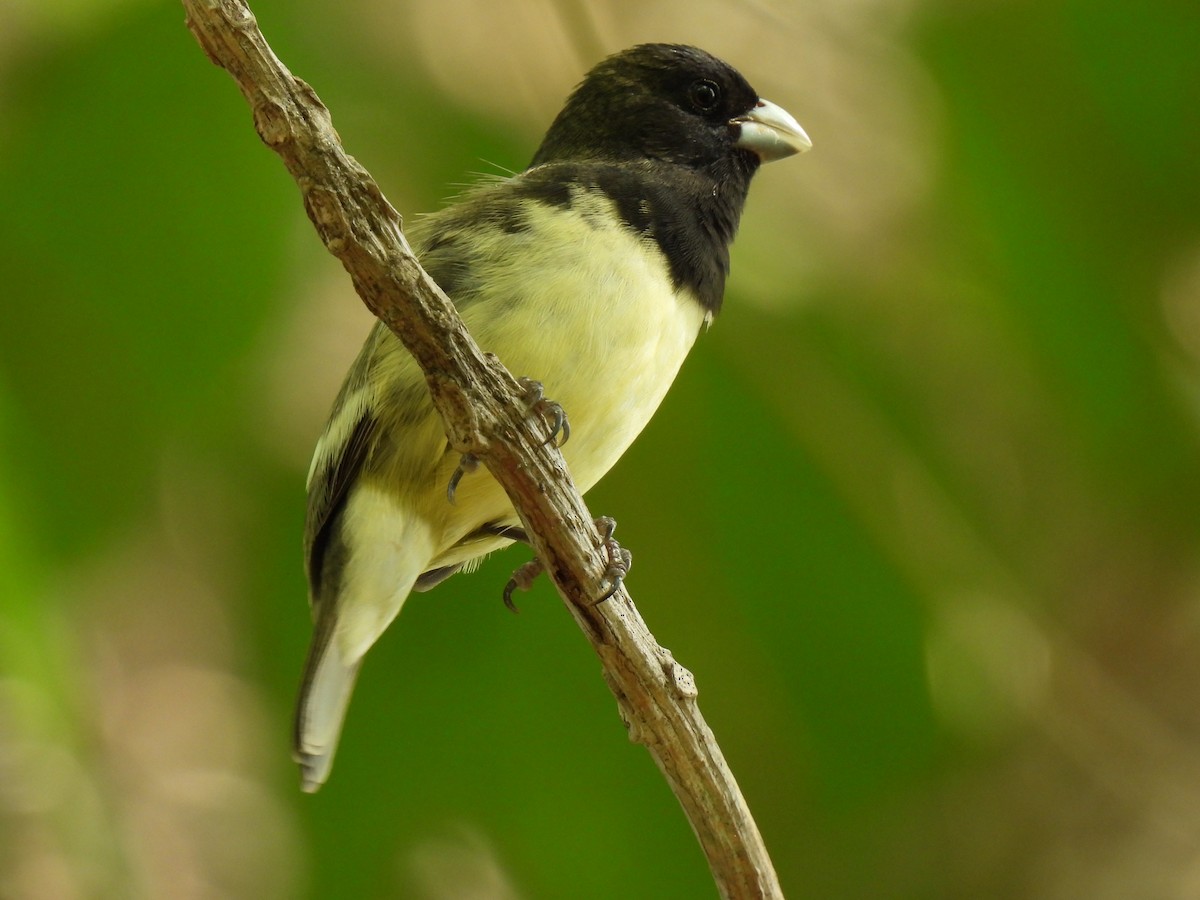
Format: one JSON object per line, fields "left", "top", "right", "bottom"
{"left": 295, "top": 44, "right": 811, "bottom": 791}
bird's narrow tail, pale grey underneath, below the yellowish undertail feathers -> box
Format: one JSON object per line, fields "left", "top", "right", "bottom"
{"left": 293, "top": 626, "right": 362, "bottom": 793}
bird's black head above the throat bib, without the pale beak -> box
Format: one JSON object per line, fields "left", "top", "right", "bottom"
{"left": 532, "top": 43, "right": 760, "bottom": 172}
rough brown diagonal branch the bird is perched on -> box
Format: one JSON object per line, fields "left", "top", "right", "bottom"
{"left": 177, "top": 0, "right": 782, "bottom": 900}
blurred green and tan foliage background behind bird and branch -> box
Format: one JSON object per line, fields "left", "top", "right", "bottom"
{"left": 0, "top": 0, "right": 1200, "bottom": 900}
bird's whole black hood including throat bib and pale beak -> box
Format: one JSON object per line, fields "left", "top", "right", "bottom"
{"left": 520, "top": 43, "right": 811, "bottom": 313}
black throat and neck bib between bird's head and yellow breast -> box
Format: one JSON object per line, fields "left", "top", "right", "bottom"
{"left": 520, "top": 157, "right": 758, "bottom": 316}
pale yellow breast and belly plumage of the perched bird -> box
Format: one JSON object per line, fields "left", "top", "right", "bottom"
{"left": 436, "top": 190, "right": 706, "bottom": 565}
